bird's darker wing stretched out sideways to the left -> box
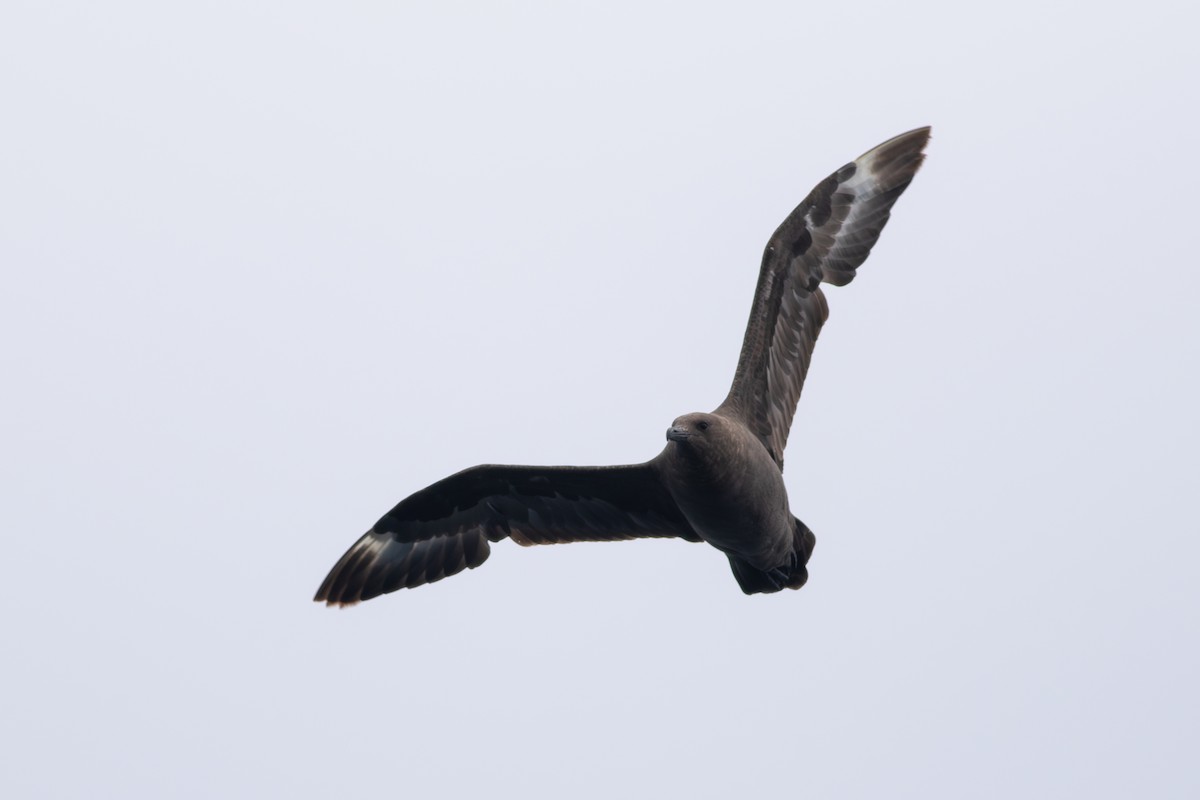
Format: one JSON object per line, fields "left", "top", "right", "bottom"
{"left": 313, "top": 463, "right": 700, "bottom": 606}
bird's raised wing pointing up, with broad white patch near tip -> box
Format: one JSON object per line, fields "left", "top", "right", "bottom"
{"left": 716, "top": 127, "right": 929, "bottom": 469}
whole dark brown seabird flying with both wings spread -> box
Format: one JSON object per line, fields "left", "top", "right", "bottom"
{"left": 314, "top": 127, "right": 930, "bottom": 606}
